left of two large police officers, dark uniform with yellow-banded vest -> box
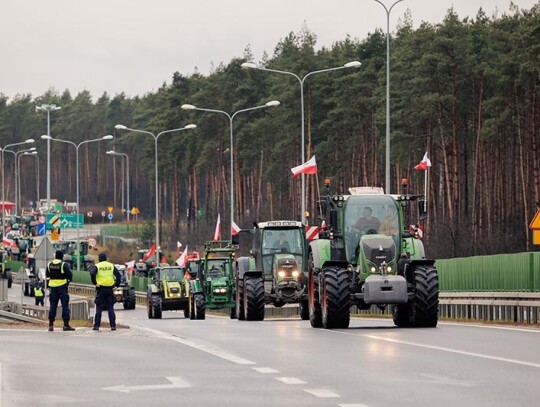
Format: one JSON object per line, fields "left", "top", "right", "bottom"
{"left": 45, "top": 250, "right": 75, "bottom": 332}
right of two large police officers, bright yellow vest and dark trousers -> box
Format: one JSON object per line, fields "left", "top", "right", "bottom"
{"left": 90, "top": 253, "right": 121, "bottom": 331}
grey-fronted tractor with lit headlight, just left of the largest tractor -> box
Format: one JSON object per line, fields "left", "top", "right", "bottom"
{"left": 235, "top": 220, "right": 309, "bottom": 321}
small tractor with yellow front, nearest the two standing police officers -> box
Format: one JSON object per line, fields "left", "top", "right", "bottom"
{"left": 147, "top": 266, "right": 205, "bottom": 319}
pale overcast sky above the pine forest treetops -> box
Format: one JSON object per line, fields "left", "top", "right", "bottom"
{"left": 0, "top": 0, "right": 539, "bottom": 99}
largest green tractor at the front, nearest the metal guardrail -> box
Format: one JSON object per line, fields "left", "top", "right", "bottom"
{"left": 308, "top": 184, "right": 439, "bottom": 328}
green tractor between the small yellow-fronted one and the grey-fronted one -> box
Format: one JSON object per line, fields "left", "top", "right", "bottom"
{"left": 201, "top": 240, "right": 236, "bottom": 319}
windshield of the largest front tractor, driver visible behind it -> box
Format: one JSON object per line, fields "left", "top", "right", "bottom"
{"left": 344, "top": 195, "right": 400, "bottom": 264}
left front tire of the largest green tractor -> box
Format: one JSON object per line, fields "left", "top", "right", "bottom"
{"left": 321, "top": 267, "right": 351, "bottom": 329}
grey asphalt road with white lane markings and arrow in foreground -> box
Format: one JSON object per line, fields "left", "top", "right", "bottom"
{"left": 0, "top": 294, "right": 540, "bottom": 407}
